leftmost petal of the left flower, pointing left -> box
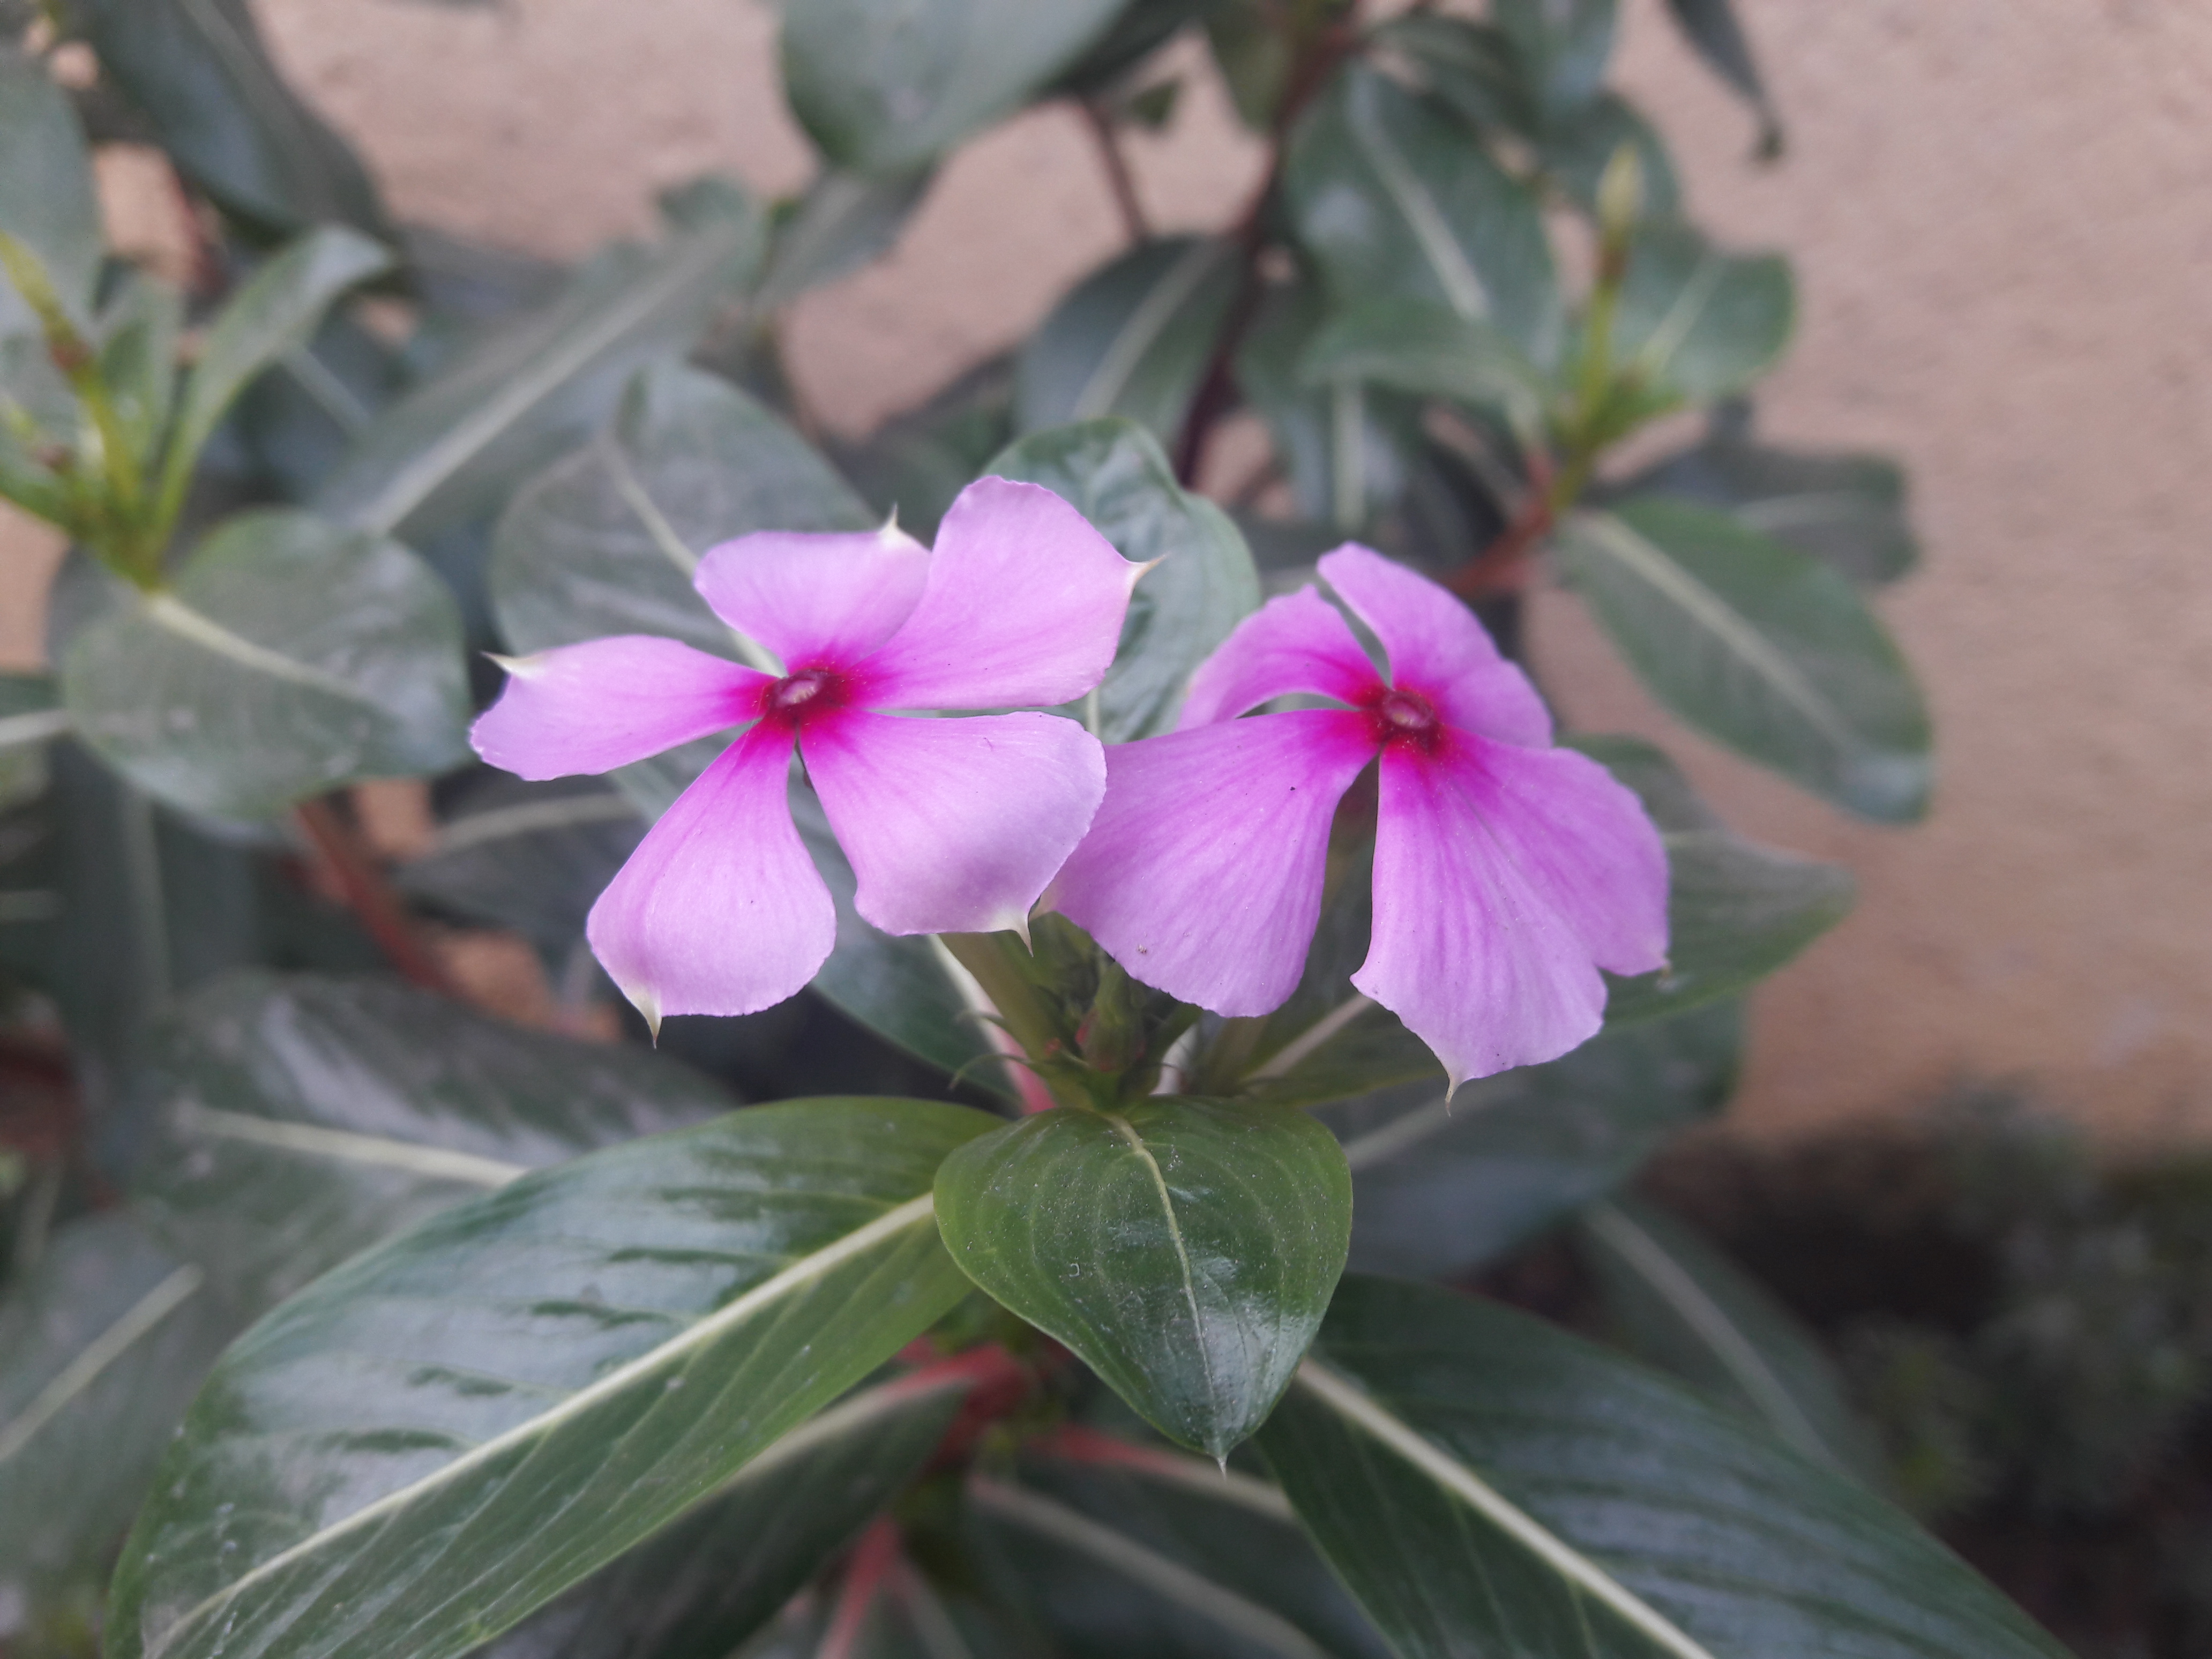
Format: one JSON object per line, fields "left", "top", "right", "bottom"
{"left": 469, "top": 633, "right": 772, "bottom": 779}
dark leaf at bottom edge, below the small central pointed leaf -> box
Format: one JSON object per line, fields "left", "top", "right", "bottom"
{"left": 967, "top": 1433, "right": 1389, "bottom": 1659}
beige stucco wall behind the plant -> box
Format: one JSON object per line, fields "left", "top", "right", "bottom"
{"left": 0, "top": 0, "right": 2212, "bottom": 1137}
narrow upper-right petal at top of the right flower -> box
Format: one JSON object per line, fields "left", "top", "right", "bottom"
{"left": 1318, "top": 542, "right": 1551, "bottom": 748}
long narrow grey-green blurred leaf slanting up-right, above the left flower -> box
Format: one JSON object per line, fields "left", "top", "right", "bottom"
{"left": 316, "top": 192, "right": 765, "bottom": 533}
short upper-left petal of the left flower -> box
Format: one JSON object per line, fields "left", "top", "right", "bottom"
{"left": 692, "top": 526, "right": 929, "bottom": 670}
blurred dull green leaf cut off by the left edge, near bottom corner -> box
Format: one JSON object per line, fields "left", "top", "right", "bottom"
{"left": 0, "top": 1210, "right": 243, "bottom": 1635}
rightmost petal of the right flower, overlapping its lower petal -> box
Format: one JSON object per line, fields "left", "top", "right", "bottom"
{"left": 1464, "top": 739, "right": 1668, "bottom": 973}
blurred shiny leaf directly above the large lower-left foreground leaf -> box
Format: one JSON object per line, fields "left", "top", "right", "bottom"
{"left": 131, "top": 973, "right": 732, "bottom": 1312}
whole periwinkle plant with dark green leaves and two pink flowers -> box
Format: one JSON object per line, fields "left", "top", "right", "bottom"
{"left": 0, "top": 0, "right": 2053, "bottom": 1659}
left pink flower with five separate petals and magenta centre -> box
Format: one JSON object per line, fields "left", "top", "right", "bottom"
{"left": 473, "top": 478, "right": 1144, "bottom": 1026}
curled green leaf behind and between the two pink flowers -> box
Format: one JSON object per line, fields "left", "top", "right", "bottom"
{"left": 984, "top": 418, "right": 1259, "bottom": 743}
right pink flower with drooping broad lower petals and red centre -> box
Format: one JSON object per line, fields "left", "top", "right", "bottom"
{"left": 1047, "top": 544, "right": 1668, "bottom": 1088}
